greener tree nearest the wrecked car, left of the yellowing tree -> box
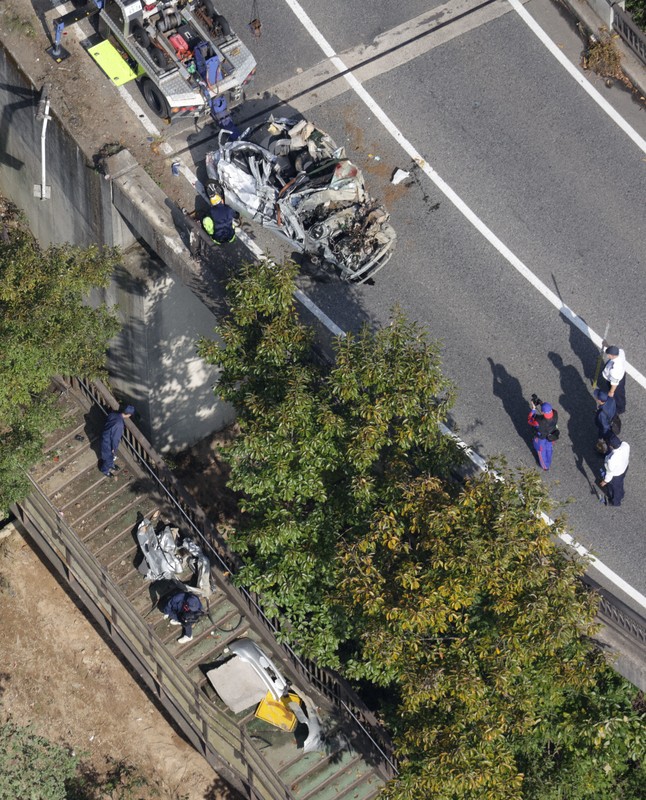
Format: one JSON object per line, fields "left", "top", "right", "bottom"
{"left": 200, "top": 262, "right": 459, "bottom": 665}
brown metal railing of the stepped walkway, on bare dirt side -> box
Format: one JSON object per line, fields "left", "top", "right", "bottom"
{"left": 16, "top": 478, "right": 293, "bottom": 800}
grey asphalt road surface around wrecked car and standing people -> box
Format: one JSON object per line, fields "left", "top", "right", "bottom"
{"left": 137, "top": 0, "right": 646, "bottom": 608}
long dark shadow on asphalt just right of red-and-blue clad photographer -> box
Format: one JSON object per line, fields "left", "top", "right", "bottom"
{"left": 547, "top": 352, "right": 602, "bottom": 494}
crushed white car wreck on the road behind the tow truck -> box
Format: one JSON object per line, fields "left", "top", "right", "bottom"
{"left": 206, "top": 117, "right": 397, "bottom": 283}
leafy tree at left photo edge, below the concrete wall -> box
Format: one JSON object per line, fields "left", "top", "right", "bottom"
{"left": 0, "top": 202, "right": 118, "bottom": 510}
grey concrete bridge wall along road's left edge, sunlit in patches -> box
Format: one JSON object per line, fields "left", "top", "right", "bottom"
{"left": 0, "top": 46, "right": 234, "bottom": 451}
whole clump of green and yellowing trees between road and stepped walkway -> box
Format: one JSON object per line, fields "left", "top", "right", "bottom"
{"left": 200, "top": 263, "right": 646, "bottom": 800}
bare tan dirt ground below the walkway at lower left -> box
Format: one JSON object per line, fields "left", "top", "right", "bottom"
{"left": 0, "top": 533, "right": 238, "bottom": 800}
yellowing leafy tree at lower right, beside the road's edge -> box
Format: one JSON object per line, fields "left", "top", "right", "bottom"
{"left": 337, "top": 473, "right": 646, "bottom": 800}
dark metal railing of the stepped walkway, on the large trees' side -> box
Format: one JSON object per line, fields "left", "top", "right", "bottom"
{"left": 66, "top": 378, "right": 398, "bottom": 780}
